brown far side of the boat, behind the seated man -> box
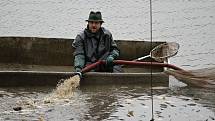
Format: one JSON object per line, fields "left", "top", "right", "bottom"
{"left": 0, "top": 37, "right": 165, "bottom": 65}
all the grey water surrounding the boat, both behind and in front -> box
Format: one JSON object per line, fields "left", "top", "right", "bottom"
{"left": 0, "top": 0, "right": 215, "bottom": 121}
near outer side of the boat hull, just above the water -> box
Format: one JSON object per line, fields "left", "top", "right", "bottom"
{"left": 0, "top": 71, "right": 169, "bottom": 87}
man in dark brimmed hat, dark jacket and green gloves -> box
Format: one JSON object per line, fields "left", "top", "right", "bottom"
{"left": 72, "top": 11, "right": 121, "bottom": 72}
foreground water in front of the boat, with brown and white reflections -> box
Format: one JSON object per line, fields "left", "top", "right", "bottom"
{"left": 0, "top": 82, "right": 215, "bottom": 121}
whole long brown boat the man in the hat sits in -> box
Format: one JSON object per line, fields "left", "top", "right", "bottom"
{"left": 0, "top": 37, "right": 169, "bottom": 86}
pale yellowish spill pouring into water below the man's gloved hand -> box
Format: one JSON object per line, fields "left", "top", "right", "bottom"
{"left": 13, "top": 75, "right": 80, "bottom": 110}
